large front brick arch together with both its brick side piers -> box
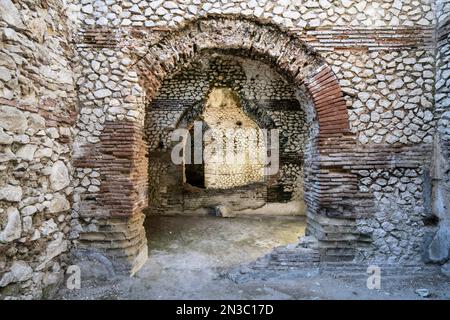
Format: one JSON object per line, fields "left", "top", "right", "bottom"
{"left": 74, "top": 17, "right": 354, "bottom": 271}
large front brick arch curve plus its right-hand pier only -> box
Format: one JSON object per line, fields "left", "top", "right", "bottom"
{"left": 134, "top": 16, "right": 358, "bottom": 260}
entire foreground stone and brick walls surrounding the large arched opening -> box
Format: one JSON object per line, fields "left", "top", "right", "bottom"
{"left": 0, "top": 0, "right": 450, "bottom": 298}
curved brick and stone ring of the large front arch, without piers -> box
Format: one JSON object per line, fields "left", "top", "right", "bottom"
{"left": 136, "top": 16, "right": 349, "bottom": 138}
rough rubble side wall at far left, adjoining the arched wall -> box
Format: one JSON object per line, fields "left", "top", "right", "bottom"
{"left": 0, "top": 0, "right": 77, "bottom": 299}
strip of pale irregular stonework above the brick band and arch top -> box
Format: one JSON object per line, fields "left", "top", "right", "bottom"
{"left": 75, "top": 0, "right": 434, "bottom": 29}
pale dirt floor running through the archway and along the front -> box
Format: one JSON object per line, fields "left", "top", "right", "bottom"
{"left": 56, "top": 217, "right": 450, "bottom": 300}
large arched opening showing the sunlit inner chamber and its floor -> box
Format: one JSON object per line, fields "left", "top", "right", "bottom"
{"left": 145, "top": 51, "right": 313, "bottom": 266}
